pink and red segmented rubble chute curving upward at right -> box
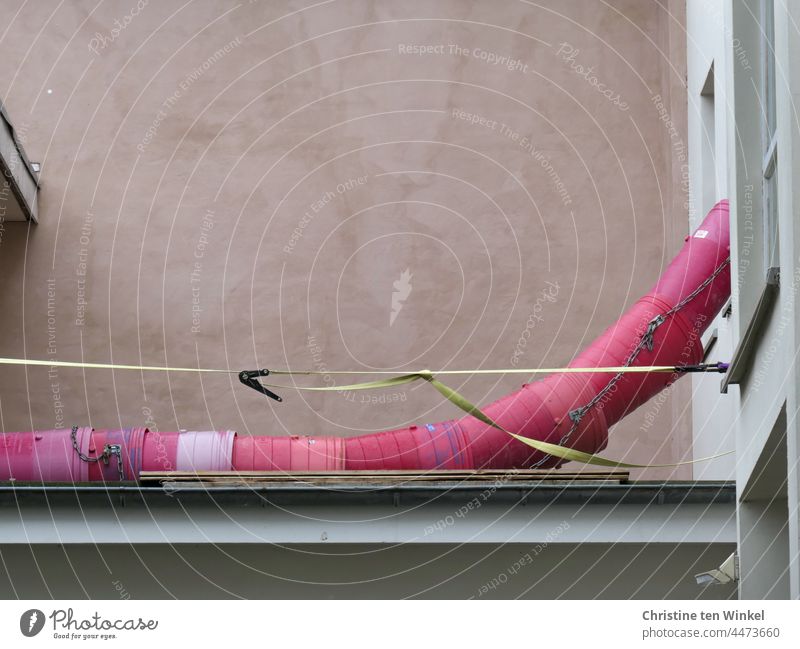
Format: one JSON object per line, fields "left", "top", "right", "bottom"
{"left": 0, "top": 201, "right": 730, "bottom": 482}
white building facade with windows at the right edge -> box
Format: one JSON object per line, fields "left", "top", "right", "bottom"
{"left": 686, "top": 0, "right": 800, "bottom": 599}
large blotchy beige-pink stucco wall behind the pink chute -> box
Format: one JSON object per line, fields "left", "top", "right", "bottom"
{"left": 0, "top": 0, "right": 691, "bottom": 477}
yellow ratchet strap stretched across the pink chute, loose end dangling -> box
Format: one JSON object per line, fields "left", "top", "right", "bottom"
{"left": 0, "top": 358, "right": 733, "bottom": 469}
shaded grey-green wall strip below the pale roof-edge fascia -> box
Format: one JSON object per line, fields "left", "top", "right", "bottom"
{"left": 0, "top": 543, "right": 735, "bottom": 596}
